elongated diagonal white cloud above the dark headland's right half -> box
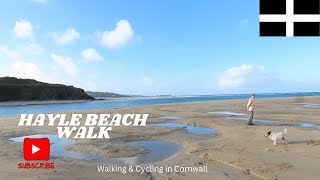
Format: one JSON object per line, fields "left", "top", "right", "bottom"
{"left": 51, "top": 54, "right": 79, "bottom": 76}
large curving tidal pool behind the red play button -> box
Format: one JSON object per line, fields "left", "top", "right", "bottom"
{"left": 9, "top": 134, "right": 181, "bottom": 165}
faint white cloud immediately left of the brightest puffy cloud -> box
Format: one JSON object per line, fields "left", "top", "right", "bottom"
{"left": 49, "top": 28, "right": 80, "bottom": 45}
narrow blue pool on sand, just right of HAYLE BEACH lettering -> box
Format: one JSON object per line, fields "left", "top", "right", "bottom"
{"left": 150, "top": 123, "right": 216, "bottom": 135}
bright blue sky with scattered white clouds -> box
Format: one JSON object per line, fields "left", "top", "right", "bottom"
{"left": 0, "top": 0, "right": 320, "bottom": 95}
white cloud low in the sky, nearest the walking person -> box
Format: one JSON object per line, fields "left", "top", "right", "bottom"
{"left": 218, "top": 64, "right": 266, "bottom": 89}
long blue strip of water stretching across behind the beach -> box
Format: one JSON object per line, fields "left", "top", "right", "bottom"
{"left": 0, "top": 93, "right": 320, "bottom": 117}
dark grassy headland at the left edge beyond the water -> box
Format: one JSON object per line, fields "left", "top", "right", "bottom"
{"left": 0, "top": 77, "right": 94, "bottom": 101}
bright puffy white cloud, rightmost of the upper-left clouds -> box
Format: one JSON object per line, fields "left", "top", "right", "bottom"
{"left": 101, "top": 20, "right": 133, "bottom": 48}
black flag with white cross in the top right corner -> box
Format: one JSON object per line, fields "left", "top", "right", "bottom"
{"left": 260, "top": 0, "right": 320, "bottom": 37}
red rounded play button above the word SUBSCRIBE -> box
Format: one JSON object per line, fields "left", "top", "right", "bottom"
{"left": 23, "top": 138, "right": 50, "bottom": 161}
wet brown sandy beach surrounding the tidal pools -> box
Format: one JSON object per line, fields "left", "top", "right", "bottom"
{"left": 0, "top": 97, "right": 320, "bottom": 180}
